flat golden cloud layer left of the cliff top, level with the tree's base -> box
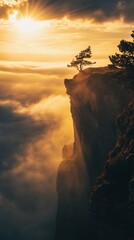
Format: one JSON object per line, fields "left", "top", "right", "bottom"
{"left": 0, "top": 62, "right": 76, "bottom": 105}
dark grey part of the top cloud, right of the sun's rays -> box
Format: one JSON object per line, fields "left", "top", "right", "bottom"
{"left": 25, "top": 0, "right": 134, "bottom": 21}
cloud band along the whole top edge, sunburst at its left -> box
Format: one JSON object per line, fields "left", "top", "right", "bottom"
{"left": 0, "top": 0, "right": 134, "bottom": 22}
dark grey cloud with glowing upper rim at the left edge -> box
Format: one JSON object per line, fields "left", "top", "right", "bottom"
{"left": 0, "top": 100, "right": 47, "bottom": 171}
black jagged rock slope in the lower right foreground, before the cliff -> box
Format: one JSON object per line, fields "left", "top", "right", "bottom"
{"left": 91, "top": 102, "right": 134, "bottom": 240}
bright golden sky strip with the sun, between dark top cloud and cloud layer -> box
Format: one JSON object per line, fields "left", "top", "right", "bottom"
{"left": 0, "top": 10, "right": 132, "bottom": 67}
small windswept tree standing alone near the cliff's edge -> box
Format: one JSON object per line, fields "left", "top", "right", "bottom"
{"left": 67, "top": 46, "right": 96, "bottom": 72}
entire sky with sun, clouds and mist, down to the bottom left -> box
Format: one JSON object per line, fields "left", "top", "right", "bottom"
{"left": 0, "top": 0, "right": 134, "bottom": 240}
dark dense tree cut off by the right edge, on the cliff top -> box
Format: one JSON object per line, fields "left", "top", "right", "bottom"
{"left": 109, "top": 31, "right": 134, "bottom": 69}
